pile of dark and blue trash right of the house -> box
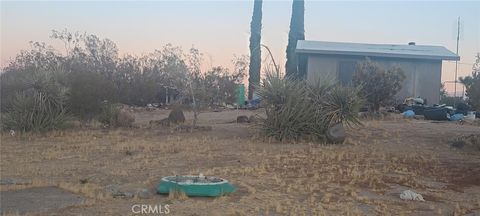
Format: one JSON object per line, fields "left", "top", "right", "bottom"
{"left": 397, "top": 98, "right": 476, "bottom": 121}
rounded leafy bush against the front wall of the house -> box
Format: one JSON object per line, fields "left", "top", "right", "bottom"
{"left": 353, "top": 58, "right": 406, "bottom": 112}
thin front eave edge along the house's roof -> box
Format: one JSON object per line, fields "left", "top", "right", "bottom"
{"left": 295, "top": 49, "right": 460, "bottom": 61}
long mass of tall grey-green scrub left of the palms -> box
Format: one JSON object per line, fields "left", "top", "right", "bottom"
{"left": 0, "top": 30, "right": 248, "bottom": 131}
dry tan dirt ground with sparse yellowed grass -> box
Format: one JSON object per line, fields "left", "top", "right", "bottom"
{"left": 0, "top": 110, "right": 480, "bottom": 215}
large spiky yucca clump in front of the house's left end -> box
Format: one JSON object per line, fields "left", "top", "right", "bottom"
{"left": 259, "top": 74, "right": 361, "bottom": 141}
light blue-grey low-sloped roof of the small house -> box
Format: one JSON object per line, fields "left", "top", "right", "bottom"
{"left": 296, "top": 40, "right": 460, "bottom": 61}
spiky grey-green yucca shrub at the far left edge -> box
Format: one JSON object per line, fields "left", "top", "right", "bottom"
{"left": 2, "top": 70, "right": 69, "bottom": 132}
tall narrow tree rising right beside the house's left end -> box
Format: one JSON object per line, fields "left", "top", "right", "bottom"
{"left": 285, "top": 0, "right": 306, "bottom": 78}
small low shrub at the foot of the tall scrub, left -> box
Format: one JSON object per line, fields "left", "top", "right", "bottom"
{"left": 98, "top": 102, "right": 135, "bottom": 127}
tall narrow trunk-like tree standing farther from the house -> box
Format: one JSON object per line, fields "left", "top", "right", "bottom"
{"left": 248, "top": 0, "right": 262, "bottom": 99}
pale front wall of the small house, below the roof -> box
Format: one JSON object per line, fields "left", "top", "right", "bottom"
{"left": 307, "top": 55, "right": 442, "bottom": 105}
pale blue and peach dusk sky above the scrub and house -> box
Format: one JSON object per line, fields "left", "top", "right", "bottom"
{"left": 0, "top": 0, "right": 480, "bottom": 93}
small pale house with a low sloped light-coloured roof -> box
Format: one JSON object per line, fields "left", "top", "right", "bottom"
{"left": 296, "top": 40, "right": 460, "bottom": 104}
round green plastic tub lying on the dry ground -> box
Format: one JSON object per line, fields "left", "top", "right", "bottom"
{"left": 157, "top": 176, "right": 236, "bottom": 197}
